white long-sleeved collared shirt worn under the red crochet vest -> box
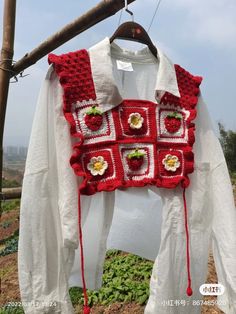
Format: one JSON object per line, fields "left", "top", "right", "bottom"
{"left": 18, "top": 38, "right": 236, "bottom": 314}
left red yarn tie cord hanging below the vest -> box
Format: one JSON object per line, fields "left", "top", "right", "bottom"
{"left": 78, "top": 191, "right": 90, "bottom": 314}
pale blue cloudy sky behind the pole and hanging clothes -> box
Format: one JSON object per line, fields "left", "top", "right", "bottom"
{"left": 0, "top": 0, "right": 236, "bottom": 146}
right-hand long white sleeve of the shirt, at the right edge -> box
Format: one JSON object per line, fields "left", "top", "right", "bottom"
{"left": 196, "top": 97, "right": 236, "bottom": 314}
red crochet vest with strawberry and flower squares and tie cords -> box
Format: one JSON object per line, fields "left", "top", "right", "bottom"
{"left": 49, "top": 50, "right": 202, "bottom": 310}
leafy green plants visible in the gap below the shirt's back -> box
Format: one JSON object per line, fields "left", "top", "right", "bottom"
{"left": 70, "top": 250, "right": 153, "bottom": 305}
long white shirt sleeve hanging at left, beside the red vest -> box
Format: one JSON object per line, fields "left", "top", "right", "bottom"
{"left": 18, "top": 68, "right": 78, "bottom": 314}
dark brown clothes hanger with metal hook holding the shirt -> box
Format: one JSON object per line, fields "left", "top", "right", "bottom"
{"left": 110, "top": 0, "right": 157, "bottom": 58}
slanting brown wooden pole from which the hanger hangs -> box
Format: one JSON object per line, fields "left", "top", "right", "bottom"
{"left": 12, "top": 0, "right": 135, "bottom": 76}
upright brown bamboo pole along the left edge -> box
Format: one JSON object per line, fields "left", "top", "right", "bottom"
{"left": 0, "top": 0, "right": 16, "bottom": 214}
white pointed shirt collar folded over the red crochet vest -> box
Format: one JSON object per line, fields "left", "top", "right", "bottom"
{"left": 89, "top": 37, "right": 180, "bottom": 111}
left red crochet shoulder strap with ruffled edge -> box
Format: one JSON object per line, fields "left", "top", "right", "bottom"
{"left": 48, "top": 49, "right": 96, "bottom": 137}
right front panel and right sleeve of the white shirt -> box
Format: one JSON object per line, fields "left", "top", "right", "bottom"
{"left": 144, "top": 96, "right": 236, "bottom": 314}
